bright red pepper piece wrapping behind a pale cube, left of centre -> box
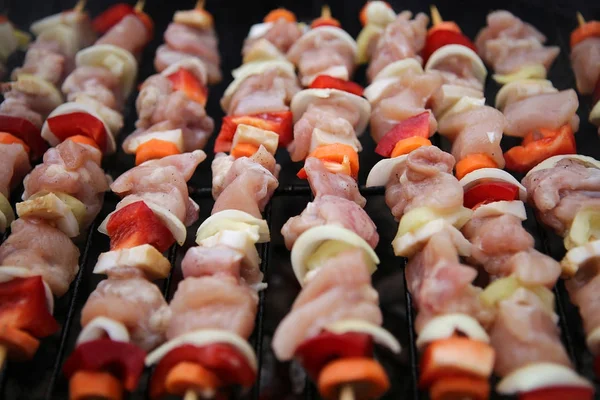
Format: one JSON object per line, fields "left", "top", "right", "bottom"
{"left": 215, "top": 111, "right": 294, "bottom": 153}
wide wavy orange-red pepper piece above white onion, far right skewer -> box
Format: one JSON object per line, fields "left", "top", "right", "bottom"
{"left": 504, "top": 124, "right": 577, "bottom": 172}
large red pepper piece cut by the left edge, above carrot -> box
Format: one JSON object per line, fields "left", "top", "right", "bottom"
{"left": 0, "top": 276, "right": 59, "bottom": 338}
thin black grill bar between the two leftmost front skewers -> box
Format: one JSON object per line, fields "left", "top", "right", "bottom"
{"left": 45, "top": 217, "right": 101, "bottom": 400}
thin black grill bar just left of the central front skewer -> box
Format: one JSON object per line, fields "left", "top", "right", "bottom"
{"left": 252, "top": 202, "right": 273, "bottom": 400}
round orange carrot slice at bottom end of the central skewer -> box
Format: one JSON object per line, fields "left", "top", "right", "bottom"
{"left": 318, "top": 357, "right": 390, "bottom": 400}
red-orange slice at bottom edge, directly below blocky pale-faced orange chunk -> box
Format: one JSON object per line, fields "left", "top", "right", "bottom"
{"left": 429, "top": 376, "right": 490, "bottom": 400}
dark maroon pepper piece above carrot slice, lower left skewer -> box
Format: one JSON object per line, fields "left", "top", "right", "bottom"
{"left": 63, "top": 339, "right": 146, "bottom": 392}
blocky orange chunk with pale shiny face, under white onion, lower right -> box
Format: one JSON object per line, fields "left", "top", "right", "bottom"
{"left": 419, "top": 336, "right": 496, "bottom": 387}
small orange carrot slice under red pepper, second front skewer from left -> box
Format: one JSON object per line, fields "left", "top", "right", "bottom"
{"left": 165, "top": 361, "right": 221, "bottom": 396}
